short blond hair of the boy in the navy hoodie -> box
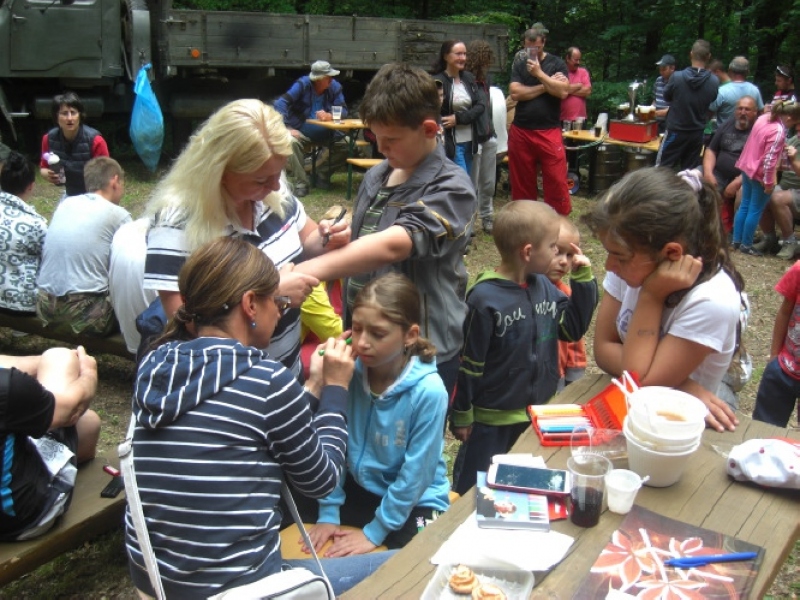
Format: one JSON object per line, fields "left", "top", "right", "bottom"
{"left": 492, "top": 200, "right": 559, "bottom": 261}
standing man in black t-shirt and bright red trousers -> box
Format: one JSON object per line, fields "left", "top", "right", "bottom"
{"left": 508, "top": 23, "right": 572, "bottom": 215}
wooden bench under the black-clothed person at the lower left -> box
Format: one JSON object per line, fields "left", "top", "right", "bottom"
{"left": 0, "top": 455, "right": 125, "bottom": 585}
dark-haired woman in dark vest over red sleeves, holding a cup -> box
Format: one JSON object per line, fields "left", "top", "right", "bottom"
{"left": 39, "top": 92, "right": 109, "bottom": 196}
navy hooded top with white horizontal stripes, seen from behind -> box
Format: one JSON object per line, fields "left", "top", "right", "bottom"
{"left": 126, "top": 338, "right": 347, "bottom": 598}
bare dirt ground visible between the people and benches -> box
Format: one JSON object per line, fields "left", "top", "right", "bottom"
{"left": 0, "top": 165, "right": 800, "bottom": 600}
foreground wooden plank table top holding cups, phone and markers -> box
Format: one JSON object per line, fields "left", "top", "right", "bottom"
{"left": 342, "top": 375, "right": 800, "bottom": 600}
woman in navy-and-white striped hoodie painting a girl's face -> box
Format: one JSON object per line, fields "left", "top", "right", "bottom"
{"left": 126, "top": 237, "right": 391, "bottom": 598}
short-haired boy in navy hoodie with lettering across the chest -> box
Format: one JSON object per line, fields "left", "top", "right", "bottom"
{"left": 450, "top": 200, "right": 598, "bottom": 494}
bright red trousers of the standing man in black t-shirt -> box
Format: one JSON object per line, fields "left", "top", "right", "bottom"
{"left": 508, "top": 125, "right": 572, "bottom": 215}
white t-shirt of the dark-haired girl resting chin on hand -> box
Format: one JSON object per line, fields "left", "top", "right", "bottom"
{"left": 603, "top": 271, "right": 740, "bottom": 391}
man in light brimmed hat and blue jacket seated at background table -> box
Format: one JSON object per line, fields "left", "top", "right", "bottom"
{"left": 275, "top": 60, "right": 347, "bottom": 197}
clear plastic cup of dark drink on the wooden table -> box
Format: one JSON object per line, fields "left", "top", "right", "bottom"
{"left": 567, "top": 454, "right": 611, "bottom": 527}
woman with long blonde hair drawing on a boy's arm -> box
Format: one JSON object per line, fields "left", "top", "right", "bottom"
{"left": 144, "top": 100, "right": 350, "bottom": 376}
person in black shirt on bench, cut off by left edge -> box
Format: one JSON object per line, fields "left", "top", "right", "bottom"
{"left": 0, "top": 347, "right": 100, "bottom": 541}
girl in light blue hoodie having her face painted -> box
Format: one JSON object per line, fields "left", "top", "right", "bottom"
{"left": 309, "top": 273, "right": 450, "bottom": 557}
